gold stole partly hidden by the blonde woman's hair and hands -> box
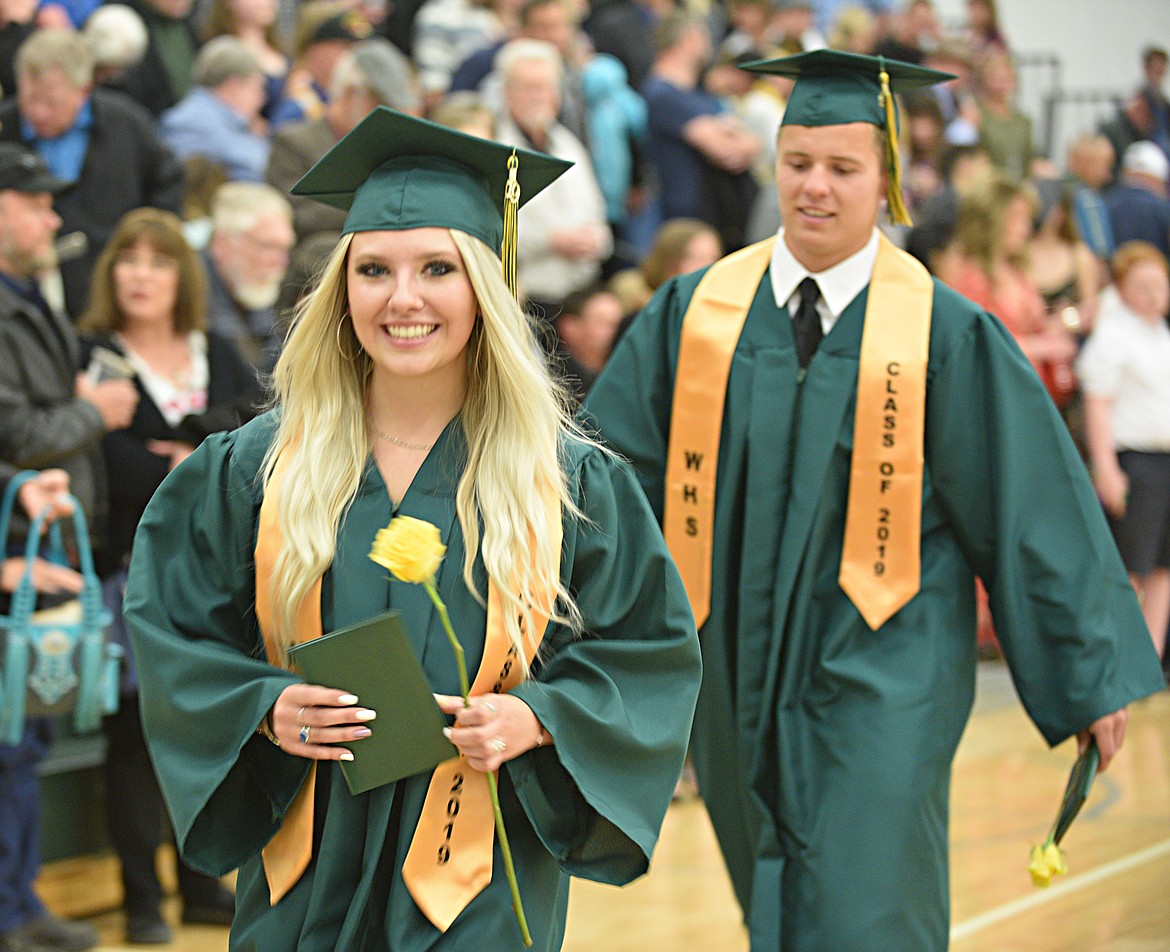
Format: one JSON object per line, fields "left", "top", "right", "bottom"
{"left": 255, "top": 467, "right": 562, "bottom": 932}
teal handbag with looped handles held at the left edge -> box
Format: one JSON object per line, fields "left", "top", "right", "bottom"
{"left": 0, "top": 470, "right": 123, "bottom": 745}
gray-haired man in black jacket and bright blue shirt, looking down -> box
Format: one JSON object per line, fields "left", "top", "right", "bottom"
{"left": 0, "top": 29, "right": 184, "bottom": 319}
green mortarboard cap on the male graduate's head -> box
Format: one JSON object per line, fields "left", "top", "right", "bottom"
{"left": 742, "top": 49, "right": 955, "bottom": 129}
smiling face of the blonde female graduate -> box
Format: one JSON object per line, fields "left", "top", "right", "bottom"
{"left": 345, "top": 228, "right": 479, "bottom": 388}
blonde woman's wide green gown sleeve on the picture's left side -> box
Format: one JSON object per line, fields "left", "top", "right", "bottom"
{"left": 124, "top": 414, "right": 309, "bottom": 875}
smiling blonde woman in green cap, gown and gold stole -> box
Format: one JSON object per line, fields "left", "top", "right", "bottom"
{"left": 126, "top": 109, "right": 700, "bottom": 952}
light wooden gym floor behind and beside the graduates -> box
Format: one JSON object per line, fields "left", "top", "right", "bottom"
{"left": 41, "top": 662, "right": 1170, "bottom": 952}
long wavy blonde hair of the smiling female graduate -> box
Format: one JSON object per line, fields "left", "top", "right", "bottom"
{"left": 264, "top": 229, "right": 587, "bottom": 661}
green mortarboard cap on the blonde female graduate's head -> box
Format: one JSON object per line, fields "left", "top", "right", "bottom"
{"left": 291, "top": 106, "right": 572, "bottom": 253}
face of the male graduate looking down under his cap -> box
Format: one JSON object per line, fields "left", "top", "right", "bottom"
{"left": 776, "top": 123, "right": 886, "bottom": 274}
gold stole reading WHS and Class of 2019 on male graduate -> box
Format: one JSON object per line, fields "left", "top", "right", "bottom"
{"left": 662, "top": 235, "right": 934, "bottom": 630}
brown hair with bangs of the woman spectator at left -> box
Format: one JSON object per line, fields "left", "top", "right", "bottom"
{"left": 77, "top": 208, "right": 207, "bottom": 334}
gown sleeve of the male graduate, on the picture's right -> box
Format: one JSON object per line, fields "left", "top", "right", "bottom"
{"left": 925, "top": 298, "right": 1163, "bottom": 745}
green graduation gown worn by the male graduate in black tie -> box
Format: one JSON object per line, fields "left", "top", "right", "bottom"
{"left": 585, "top": 263, "right": 1162, "bottom": 952}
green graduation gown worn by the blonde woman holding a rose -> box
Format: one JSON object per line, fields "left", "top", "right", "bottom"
{"left": 125, "top": 416, "right": 700, "bottom": 952}
